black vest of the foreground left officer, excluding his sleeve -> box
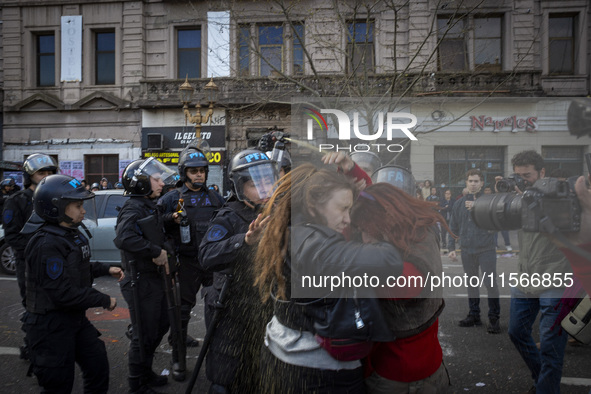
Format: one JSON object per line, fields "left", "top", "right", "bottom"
{"left": 25, "top": 224, "right": 92, "bottom": 314}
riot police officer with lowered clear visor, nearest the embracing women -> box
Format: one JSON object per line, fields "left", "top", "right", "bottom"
{"left": 199, "top": 149, "right": 277, "bottom": 393}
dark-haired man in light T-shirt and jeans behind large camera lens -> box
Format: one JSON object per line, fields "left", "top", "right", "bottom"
{"left": 495, "top": 150, "right": 571, "bottom": 394}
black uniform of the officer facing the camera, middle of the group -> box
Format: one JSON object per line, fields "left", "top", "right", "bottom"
{"left": 158, "top": 184, "right": 224, "bottom": 336}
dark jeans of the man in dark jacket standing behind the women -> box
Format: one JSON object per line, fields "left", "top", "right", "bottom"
{"left": 462, "top": 249, "right": 501, "bottom": 319}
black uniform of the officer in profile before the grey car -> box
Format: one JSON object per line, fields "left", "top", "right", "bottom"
{"left": 114, "top": 196, "right": 169, "bottom": 391}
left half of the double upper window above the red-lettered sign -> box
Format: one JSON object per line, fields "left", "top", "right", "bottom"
{"left": 437, "top": 17, "right": 468, "bottom": 71}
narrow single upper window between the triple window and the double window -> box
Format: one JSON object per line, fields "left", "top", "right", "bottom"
{"left": 347, "top": 22, "right": 375, "bottom": 74}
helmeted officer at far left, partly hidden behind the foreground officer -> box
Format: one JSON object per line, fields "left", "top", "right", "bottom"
{"left": 2, "top": 153, "right": 58, "bottom": 303}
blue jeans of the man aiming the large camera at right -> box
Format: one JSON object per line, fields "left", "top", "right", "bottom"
{"left": 509, "top": 288, "right": 568, "bottom": 394}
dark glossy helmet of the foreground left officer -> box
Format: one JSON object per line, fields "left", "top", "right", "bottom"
{"left": 33, "top": 175, "right": 94, "bottom": 223}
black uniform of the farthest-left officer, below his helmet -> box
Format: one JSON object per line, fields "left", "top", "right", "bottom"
{"left": 2, "top": 188, "right": 33, "bottom": 303}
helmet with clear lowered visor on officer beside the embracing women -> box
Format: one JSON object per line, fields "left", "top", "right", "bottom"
{"left": 228, "top": 149, "right": 278, "bottom": 201}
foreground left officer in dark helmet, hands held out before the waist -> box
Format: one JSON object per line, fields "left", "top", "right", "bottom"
{"left": 25, "top": 175, "right": 123, "bottom": 393}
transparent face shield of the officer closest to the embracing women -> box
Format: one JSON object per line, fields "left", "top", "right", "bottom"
{"left": 234, "top": 163, "right": 278, "bottom": 204}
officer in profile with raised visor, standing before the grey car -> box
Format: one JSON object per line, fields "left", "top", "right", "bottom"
{"left": 114, "top": 157, "right": 176, "bottom": 393}
